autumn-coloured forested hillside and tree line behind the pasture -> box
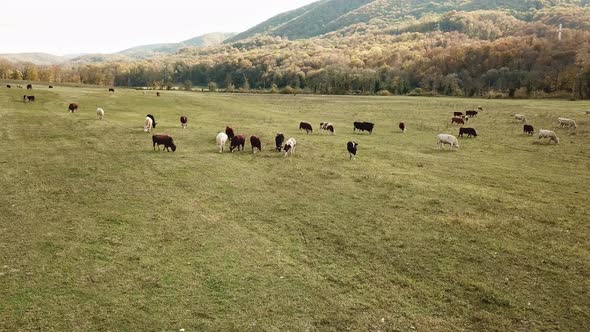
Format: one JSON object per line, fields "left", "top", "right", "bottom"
{"left": 0, "top": 0, "right": 590, "bottom": 98}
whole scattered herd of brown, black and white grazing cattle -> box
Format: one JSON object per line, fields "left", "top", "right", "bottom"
{"left": 6, "top": 84, "right": 590, "bottom": 159}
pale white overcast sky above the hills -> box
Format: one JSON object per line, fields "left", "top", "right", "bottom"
{"left": 0, "top": 0, "right": 316, "bottom": 55}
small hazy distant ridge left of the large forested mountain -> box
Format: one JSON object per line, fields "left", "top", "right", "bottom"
{"left": 116, "top": 32, "right": 235, "bottom": 59}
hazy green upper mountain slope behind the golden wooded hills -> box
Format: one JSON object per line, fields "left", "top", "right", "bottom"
{"left": 226, "top": 0, "right": 590, "bottom": 43}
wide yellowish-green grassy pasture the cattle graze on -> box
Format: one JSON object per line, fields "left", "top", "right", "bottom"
{"left": 0, "top": 86, "right": 590, "bottom": 331}
